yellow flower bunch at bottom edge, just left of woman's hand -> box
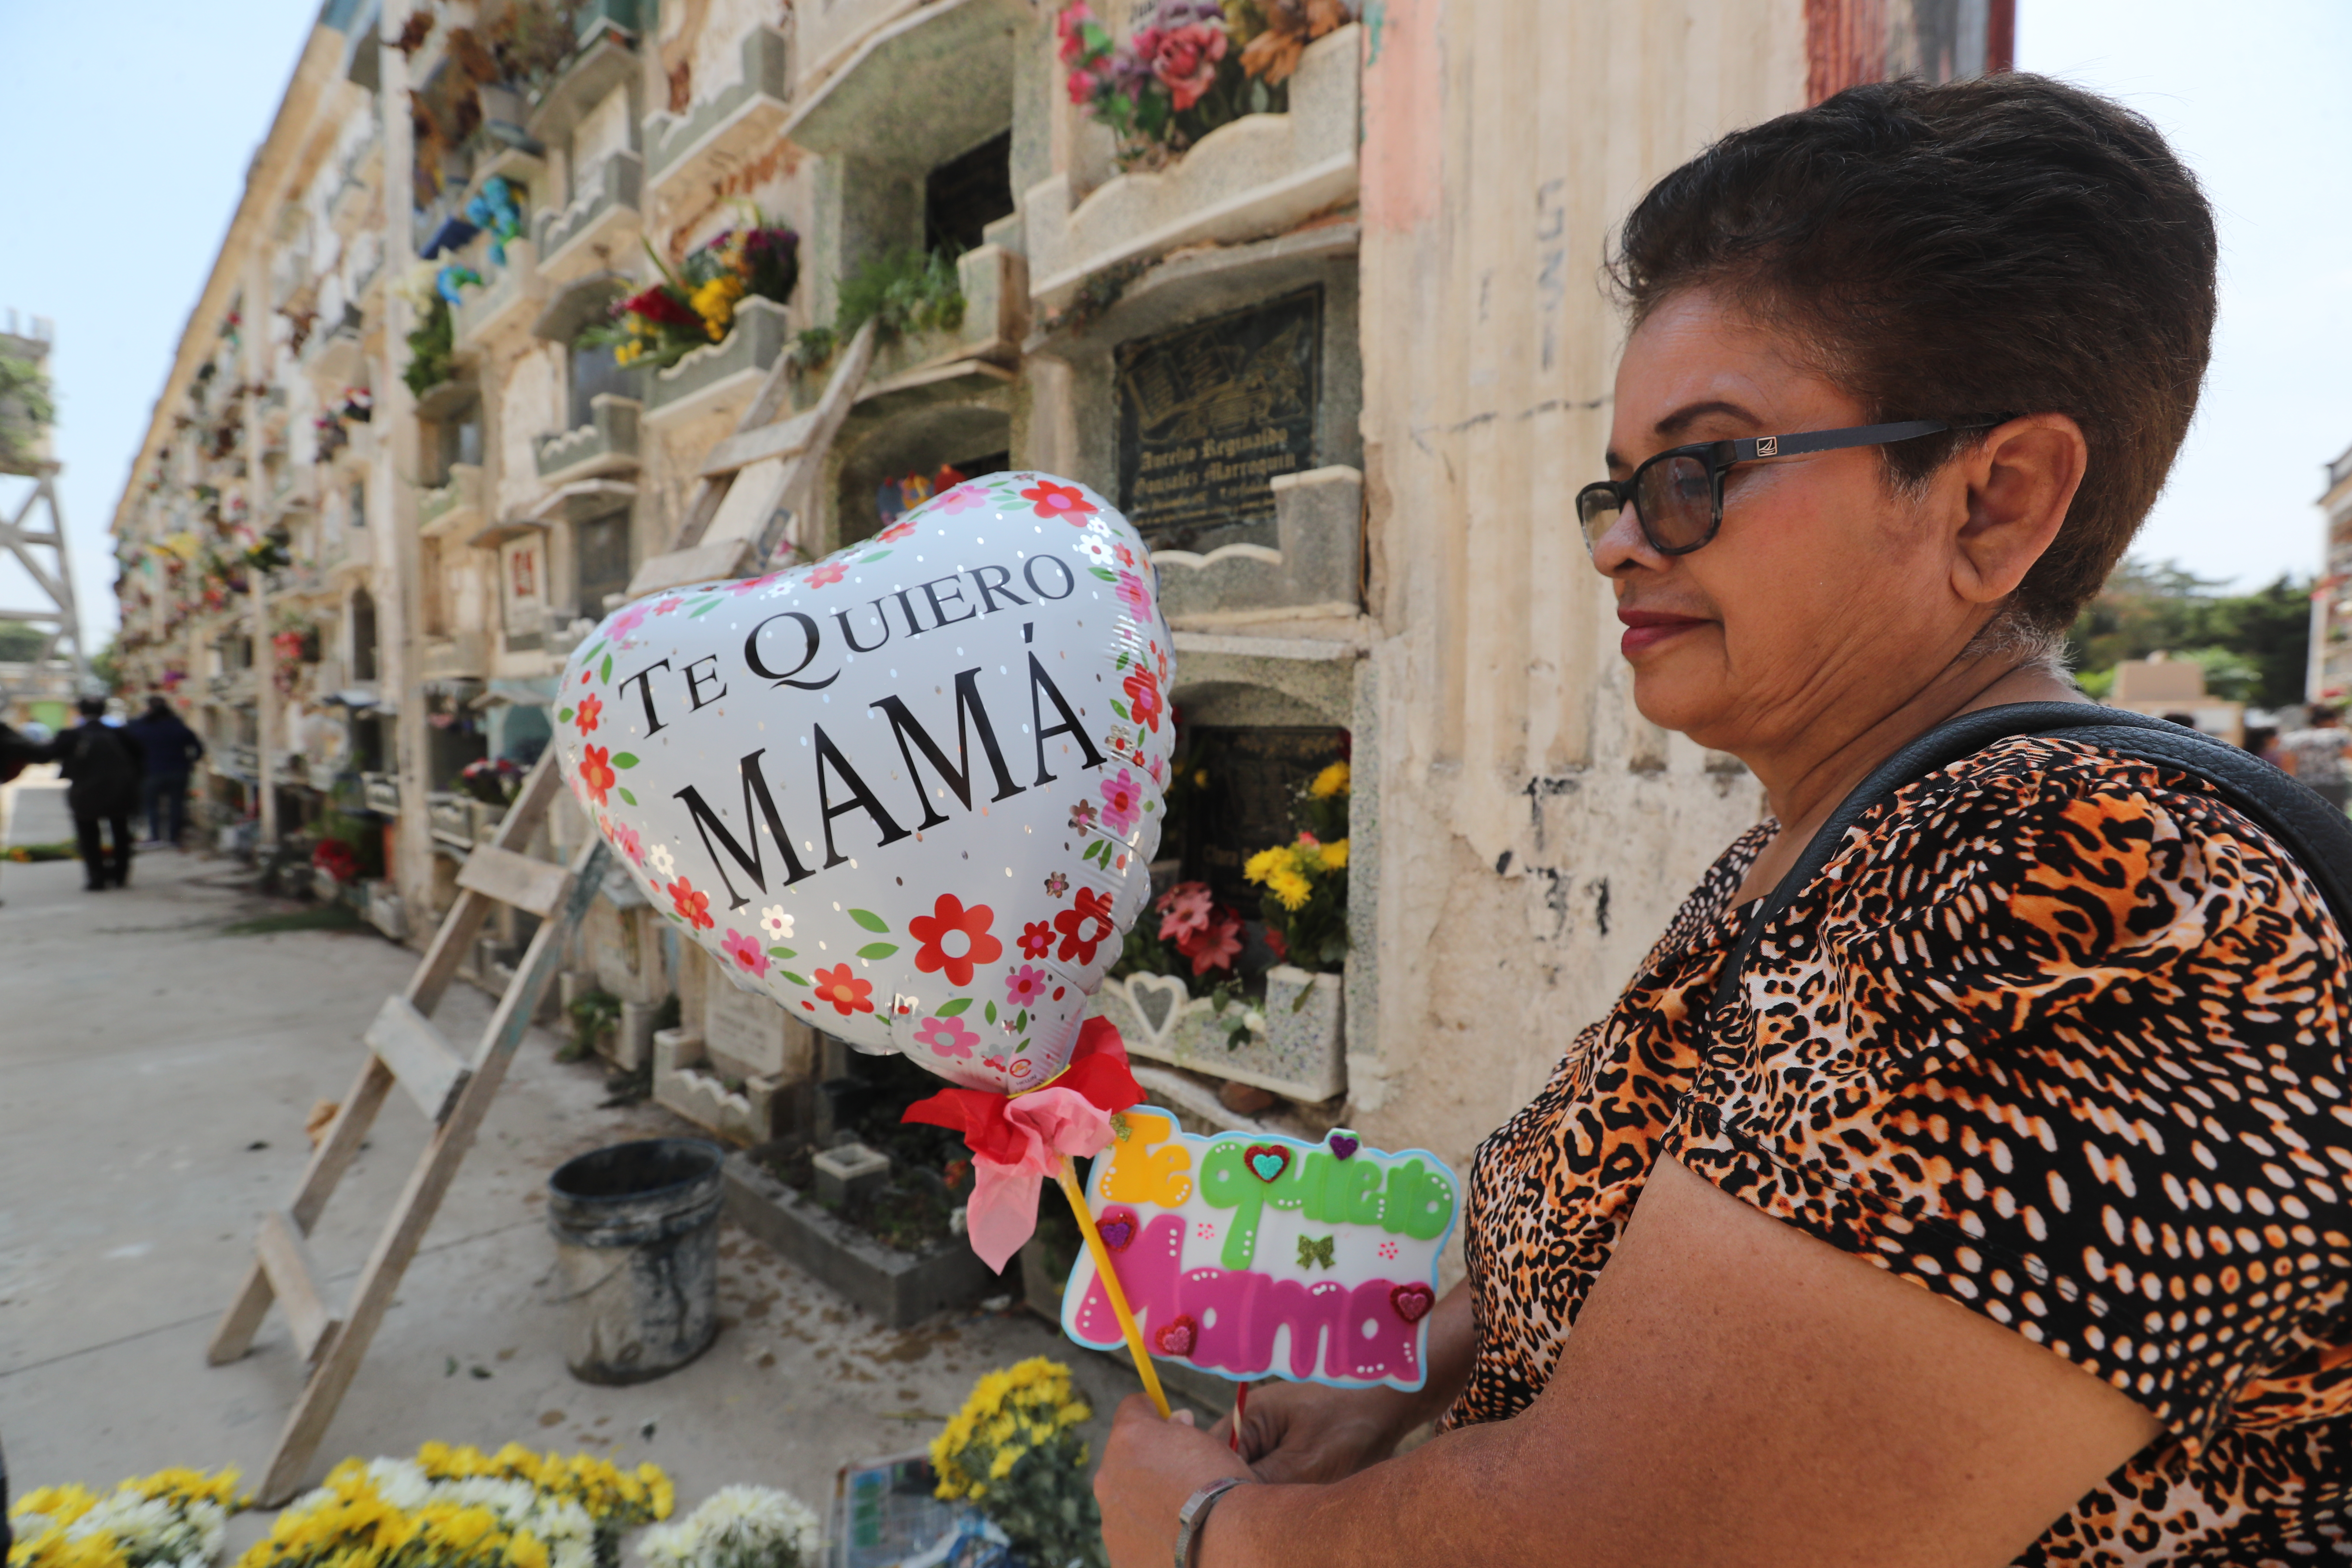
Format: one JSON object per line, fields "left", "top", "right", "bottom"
{"left": 931, "top": 1357, "right": 1108, "bottom": 1568}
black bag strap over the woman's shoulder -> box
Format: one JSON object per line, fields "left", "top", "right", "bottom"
{"left": 1710, "top": 703, "right": 2352, "bottom": 1011}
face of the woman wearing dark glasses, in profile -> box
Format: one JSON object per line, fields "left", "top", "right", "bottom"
{"left": 1592, "top": 289, "right": 1990, "bottom": 757}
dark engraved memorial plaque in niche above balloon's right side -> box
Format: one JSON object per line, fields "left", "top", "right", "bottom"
{"left": 1117, "top": 289, "right": 1322, "bottom": 552}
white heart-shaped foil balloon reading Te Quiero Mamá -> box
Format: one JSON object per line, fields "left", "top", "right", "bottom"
{"left": 555, "top": 472, "right": 1176, "bottom": 1091}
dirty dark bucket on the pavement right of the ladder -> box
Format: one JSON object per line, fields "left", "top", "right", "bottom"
{"left": 548, "top": 1138, "right": 727, "bottom": 1382}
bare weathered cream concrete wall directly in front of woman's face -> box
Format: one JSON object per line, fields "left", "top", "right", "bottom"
{"left": 1350, "top": 0, "right": 1804, "bottom": 1159}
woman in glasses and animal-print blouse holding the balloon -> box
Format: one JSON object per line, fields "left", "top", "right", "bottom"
{"left": 1096, "top": 75, "right": 2352, "bottom": 1568}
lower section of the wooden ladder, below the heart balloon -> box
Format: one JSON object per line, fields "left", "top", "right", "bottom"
{"left": 205, "top": 745, "right": 609, "bottom": 1507}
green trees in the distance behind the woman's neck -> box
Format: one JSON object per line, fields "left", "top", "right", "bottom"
{"left": 2067, "top": 557, "right": 2312, "bottom": 707}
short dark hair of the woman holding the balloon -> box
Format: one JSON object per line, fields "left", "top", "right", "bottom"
{"left": 1609, "top": 75, "right": 2216, "bottom": 635}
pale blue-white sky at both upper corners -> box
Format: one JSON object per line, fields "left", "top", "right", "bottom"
{"left": 0, "top": 0, "right": 2352, "bottom": 646}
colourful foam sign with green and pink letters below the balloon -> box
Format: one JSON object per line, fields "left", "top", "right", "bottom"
{"left": 1061, "top": 1107, "right": 1461, "bottom": 1389}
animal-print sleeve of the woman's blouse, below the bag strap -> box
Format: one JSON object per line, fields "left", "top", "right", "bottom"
{"left": 1663, "top": 741, "right": 2352, "bottom": 1448}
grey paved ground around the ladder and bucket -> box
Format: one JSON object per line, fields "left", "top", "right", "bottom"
{"left": 0, "top": 790, "right": 1171, "bottom": 1530}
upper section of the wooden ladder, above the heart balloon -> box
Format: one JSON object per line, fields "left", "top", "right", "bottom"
{"left": 628, "top": 320, "right": 875, "bottom": 600}
